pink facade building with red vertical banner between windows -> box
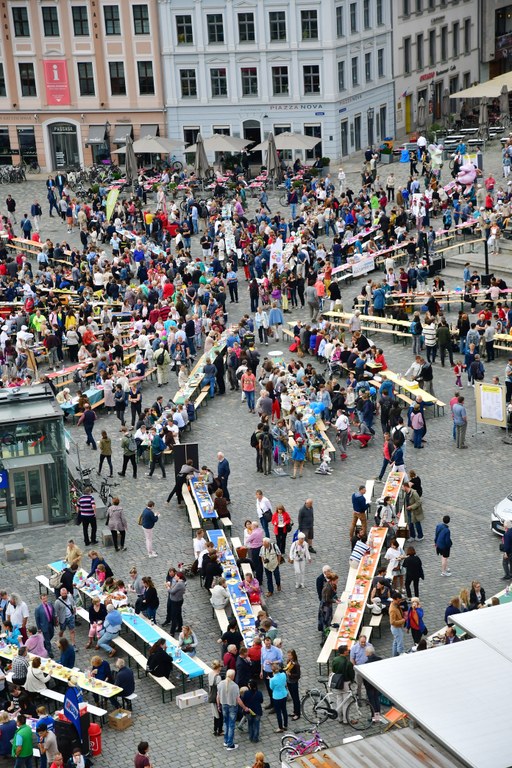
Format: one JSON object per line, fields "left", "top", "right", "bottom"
{"left": 0, "top": 0, "right": 165, "bottom": 170}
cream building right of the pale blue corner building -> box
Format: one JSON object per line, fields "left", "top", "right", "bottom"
{"left": 393, "top": 0, "right": 480, "bottom": 135}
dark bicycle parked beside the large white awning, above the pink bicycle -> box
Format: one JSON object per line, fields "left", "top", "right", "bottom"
{"left": 301, "top": 679, "right": 373, "bottom": 731}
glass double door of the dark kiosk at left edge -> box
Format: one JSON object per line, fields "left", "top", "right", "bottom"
{"left": 9, "top": 467, "right": 48, "bottom": 528}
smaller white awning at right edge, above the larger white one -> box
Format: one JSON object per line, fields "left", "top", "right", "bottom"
{"left": 452, "top": 602, "right": 512, "bottom": 660}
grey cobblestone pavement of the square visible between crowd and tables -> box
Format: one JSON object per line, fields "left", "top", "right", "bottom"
{"left": 0, "top": 140, "right": 511, "bottom": 768}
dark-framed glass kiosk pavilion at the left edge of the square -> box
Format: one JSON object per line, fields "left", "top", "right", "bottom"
{"left": 0, "top": 385, "right": 71, "bottom": 532}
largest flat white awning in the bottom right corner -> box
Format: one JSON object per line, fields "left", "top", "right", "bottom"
{"left": 358, "top": 636, "right": 512, "bottom": 768}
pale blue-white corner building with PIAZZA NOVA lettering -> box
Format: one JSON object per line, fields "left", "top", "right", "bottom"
{"left": 158, "top": 0, "right": 395, "bottom": 161}
